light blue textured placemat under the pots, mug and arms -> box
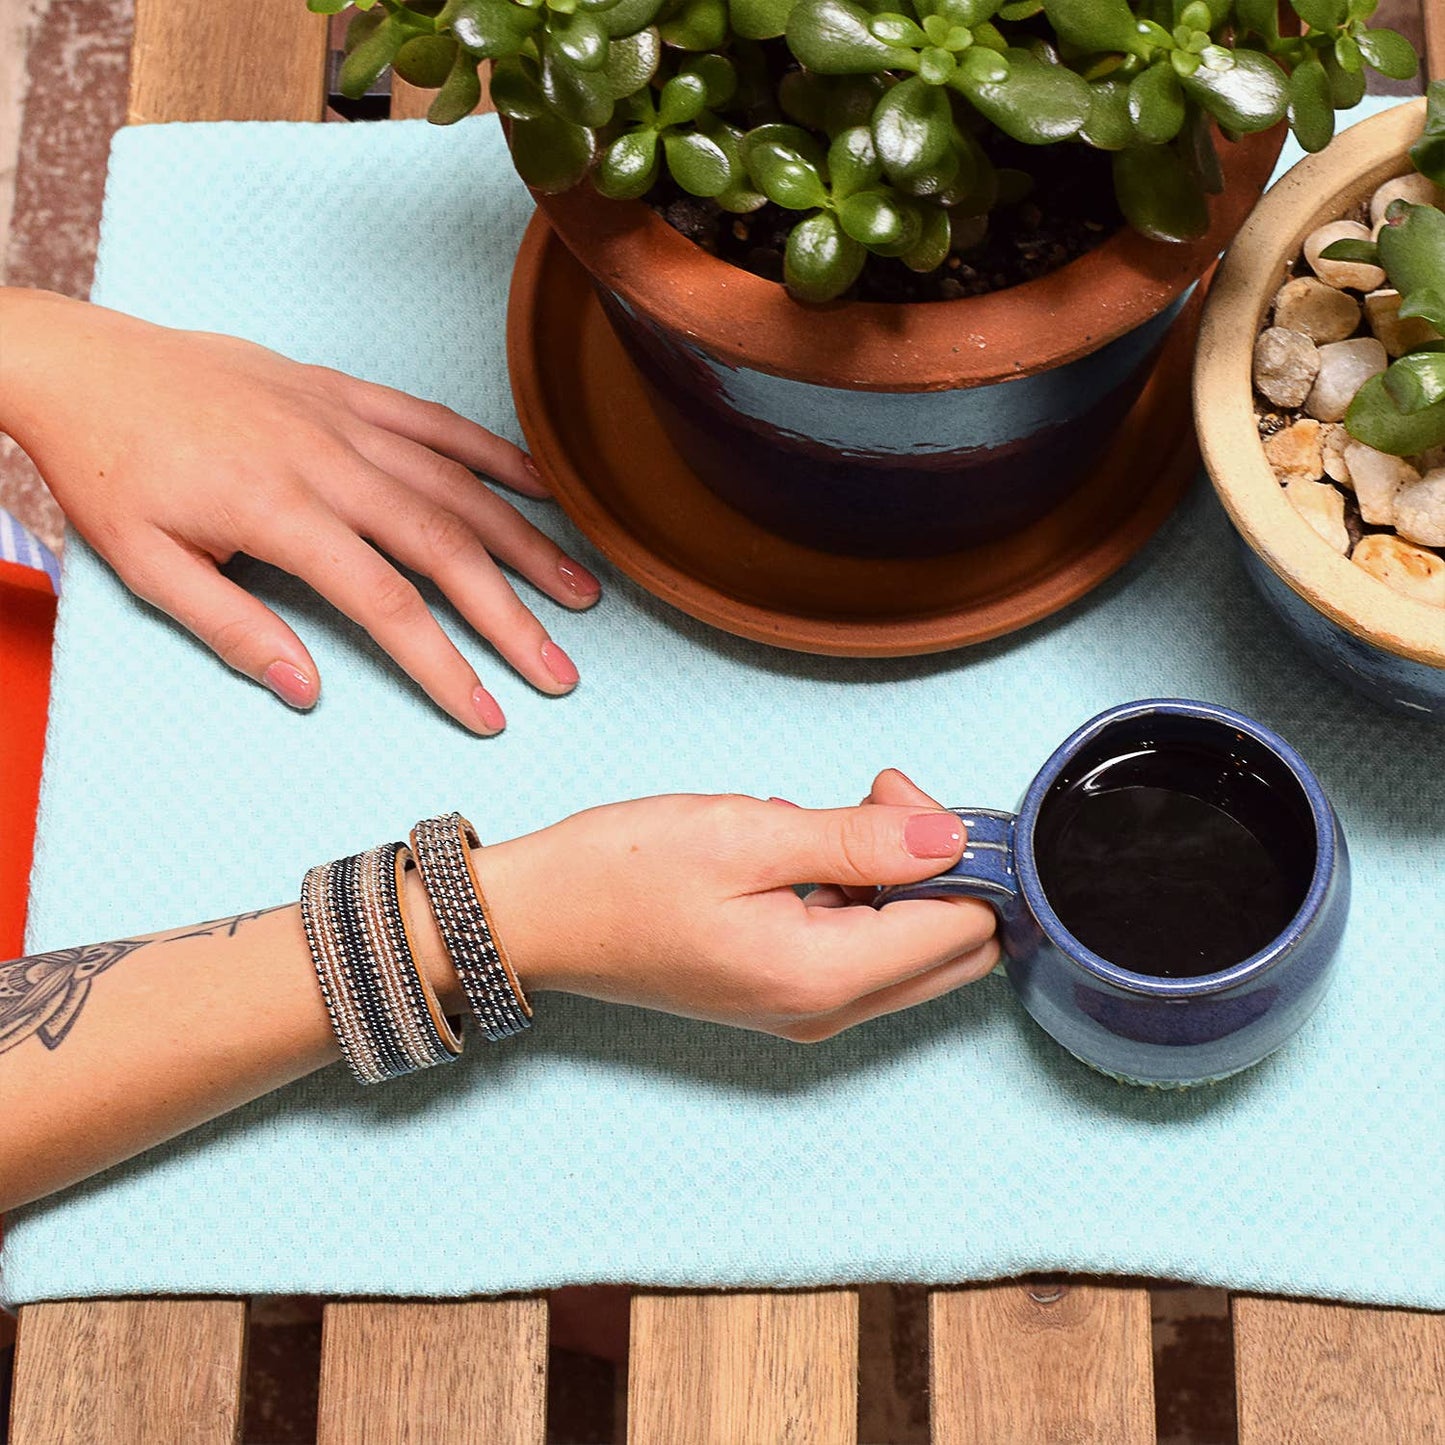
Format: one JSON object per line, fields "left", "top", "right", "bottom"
{"left": 4, "top": 96, "right": 1445, "bottom": 1306}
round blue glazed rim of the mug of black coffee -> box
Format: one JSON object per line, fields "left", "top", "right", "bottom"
{"left": 1014, "top": 698, "right": 1337, "bottom": 998}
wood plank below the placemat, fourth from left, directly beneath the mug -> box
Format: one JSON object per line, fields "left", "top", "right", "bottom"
{"left": 929, "top": 1280, "right": 1155, "bottom": 1445}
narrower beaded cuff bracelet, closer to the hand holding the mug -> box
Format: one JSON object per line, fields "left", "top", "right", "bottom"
{"left": 412, "top": 812, "right": 532, "bottom": 1042}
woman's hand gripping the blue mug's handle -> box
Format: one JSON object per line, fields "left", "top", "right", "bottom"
{"left": 477, "top": 770, "right": 998, "bottom": 1042}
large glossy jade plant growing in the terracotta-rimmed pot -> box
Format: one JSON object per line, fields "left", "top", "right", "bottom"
{"left": 308, "top": 0, "right": 1419, "bottom": 301}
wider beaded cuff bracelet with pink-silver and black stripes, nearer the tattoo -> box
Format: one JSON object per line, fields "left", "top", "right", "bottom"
{"left": 301, "top": 842, "right": 461, "bottom": 1084}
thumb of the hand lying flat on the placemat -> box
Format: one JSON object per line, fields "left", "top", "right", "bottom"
{"left": 117, "top": 543, "right": 321, "bottom": 708}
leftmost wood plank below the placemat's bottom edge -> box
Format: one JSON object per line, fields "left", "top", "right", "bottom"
{"left": 10, "top": 1299, "right": 246, "bottom": 1445}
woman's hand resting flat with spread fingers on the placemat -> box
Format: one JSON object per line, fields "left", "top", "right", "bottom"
{"left": 0, "top": 289, "right": 600, "bottom": 734}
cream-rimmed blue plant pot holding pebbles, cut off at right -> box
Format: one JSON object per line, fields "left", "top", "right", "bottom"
{"left": 1194, "top": 100, "right": 1445, "bottom": 718}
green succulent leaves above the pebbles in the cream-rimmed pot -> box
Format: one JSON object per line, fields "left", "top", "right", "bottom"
{"left": 1321, "top": 81, "right": 1445, "bottom": 457}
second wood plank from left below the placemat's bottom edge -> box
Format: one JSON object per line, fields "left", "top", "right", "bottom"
{"left": 316, "top": 1298, "right": 546, "bottom": 1445}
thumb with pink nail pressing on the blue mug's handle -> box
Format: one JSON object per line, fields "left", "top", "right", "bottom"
{"left": 764, "top": 803, "right": 967, "bottom": 887}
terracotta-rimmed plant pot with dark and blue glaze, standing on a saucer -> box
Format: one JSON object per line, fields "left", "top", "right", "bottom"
{"left": 538, "top": 129, "right": 1283, "bottom": 556}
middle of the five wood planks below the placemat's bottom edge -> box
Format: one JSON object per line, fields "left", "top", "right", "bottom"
{"left": 627, "top": 1289, "right": 858, "bottom": 1445}
